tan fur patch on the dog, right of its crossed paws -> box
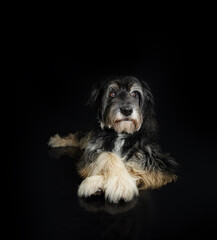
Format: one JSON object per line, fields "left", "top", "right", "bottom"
{"left": 126, "top": 162, "right": 177, "bottom": 189}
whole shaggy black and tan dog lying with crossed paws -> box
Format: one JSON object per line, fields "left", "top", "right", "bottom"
{"left": 48, "top": 77, "right": 177, "bottom": 203}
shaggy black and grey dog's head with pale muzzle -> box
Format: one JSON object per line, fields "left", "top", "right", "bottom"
{"left": 89, "top": 76, "right": 153, "bottom": 134}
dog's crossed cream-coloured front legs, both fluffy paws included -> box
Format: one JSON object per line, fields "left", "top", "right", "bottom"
{"left": 78, "top": 152, "right": 138, "bottom": 203}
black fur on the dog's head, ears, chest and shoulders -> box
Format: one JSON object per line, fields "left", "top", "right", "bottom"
{"left": 78, "top": 76, "right": 178, "bottom": 174}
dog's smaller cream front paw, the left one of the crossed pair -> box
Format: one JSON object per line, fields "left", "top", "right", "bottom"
{"left": 78, "top": 176, "right": 103, "bottom": 197}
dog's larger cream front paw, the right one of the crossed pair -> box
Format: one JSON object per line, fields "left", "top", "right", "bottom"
{"left": 104, "top": 176, "right": 138, "bottom": 203}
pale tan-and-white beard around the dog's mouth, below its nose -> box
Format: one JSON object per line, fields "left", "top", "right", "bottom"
{"left": 105, "top": 110, "right": 142, "bottom": 134}
